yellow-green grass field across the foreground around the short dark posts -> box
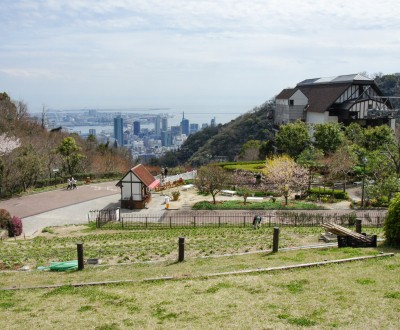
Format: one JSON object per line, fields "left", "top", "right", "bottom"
{"left": 0, "top": 228, "right": 400, "bottom": 329}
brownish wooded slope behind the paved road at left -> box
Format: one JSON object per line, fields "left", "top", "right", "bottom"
{"left": 0, "top": 93, "right": 132, "bottom": 196}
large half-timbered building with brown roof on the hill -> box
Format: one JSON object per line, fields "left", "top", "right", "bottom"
{"left": 274, "top": 74, "right": 395, "bottom": 128}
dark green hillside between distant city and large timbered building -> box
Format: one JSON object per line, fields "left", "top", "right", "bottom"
{"left": 178, "top": 101, "right": 273, "bottom": 166}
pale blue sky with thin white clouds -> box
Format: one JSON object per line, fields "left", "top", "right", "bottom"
{"left": 0, "top": 0, "right": 400, "bottom": 124}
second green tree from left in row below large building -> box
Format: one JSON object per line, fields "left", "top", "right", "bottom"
{"left": 313, "top": 123, "right": 344, "bottom": 155}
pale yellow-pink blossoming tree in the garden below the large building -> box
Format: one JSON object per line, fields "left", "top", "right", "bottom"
{"left": 264, "top": 155, "right": 308, "bottom": 205}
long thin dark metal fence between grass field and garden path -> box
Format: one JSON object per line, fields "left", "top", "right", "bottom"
{"left": 89, "top": 210, "right": 386, "bottom": 229}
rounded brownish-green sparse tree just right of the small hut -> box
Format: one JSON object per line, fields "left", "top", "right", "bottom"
{"left": 195, "top": 164, "right": 232, "bottom": 204}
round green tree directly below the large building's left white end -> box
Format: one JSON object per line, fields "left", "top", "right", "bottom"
{"left": 275, "top": 120, "right": 311, "bottom": 157}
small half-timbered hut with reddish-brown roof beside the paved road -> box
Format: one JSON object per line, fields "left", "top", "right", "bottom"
{"left": 116, "top": 164, "right": 160, "bottom": 209}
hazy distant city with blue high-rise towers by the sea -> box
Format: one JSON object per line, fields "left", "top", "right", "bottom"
{"left": 36, "top": 109, "right": 217, "bottom": 162}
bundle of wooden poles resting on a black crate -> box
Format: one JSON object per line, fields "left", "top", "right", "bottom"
{"left": 322, "top": 223, "right": 377, "bottom": 247}
